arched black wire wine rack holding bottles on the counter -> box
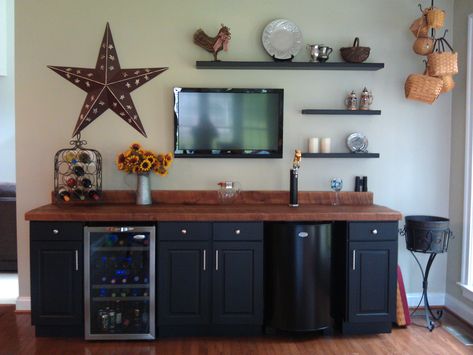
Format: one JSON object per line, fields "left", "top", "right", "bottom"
{"left": 54, "top": 134, "right": 102, "bottom": 203}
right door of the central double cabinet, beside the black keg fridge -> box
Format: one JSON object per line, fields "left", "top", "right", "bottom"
{"left": 213, "top": 242, "right": 263, "bottom": 325}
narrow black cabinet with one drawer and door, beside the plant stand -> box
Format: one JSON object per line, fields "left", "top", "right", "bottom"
{"left": 342, "top": 222, "right": 398, "bottom": 333}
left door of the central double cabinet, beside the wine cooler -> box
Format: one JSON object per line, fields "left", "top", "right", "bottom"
{"left": 157, "top": 241, "right": 210, "bottom": 325}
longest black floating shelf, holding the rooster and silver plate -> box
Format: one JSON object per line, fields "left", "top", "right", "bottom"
{"left": 195, "top": 61, "right": 384, "bottom": 71}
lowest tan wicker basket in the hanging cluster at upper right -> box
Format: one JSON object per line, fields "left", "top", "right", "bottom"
{"left": 404, "top": 74, "right": 443, "bottom": 104}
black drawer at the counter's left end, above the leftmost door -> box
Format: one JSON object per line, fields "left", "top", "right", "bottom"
{"left": 30, "top": 222, "right": 84, "bottom": 241}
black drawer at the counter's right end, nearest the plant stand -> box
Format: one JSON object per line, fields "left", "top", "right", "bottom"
{"left": 348, "top": 222, "right": 398, "bottom": 241}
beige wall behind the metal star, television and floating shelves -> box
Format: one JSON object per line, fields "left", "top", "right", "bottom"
{"left": 16, "top": 0, "right": 453, "bottom": 306}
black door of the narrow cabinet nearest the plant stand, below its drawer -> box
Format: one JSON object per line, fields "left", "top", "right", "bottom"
{"left": 348, "top": 242, "right": 397, "bottom": 323}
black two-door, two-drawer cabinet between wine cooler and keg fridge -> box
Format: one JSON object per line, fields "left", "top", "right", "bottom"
{"left": 157, "top": 222, "right": 263, "bottom": 336}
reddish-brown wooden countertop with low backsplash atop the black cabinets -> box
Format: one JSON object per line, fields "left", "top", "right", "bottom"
{"left": 25, "top": 191, "right": 402, "bottom": 222}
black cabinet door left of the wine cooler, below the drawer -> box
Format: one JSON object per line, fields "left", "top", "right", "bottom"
{"left": 31, "top": 241, "right": 84, "bottom": 325}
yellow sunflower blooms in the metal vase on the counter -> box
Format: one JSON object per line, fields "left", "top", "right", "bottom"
{"left": 116, "top": 143, "right": 173, "bottom": 176}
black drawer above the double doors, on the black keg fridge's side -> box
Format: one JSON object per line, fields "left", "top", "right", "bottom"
{"left": 213, "top": 222, "right": 263, "bottom": 241}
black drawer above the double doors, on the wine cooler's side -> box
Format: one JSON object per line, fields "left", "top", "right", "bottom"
{"left": 158, "top": 222, "right": 212, "bottom": 240}
